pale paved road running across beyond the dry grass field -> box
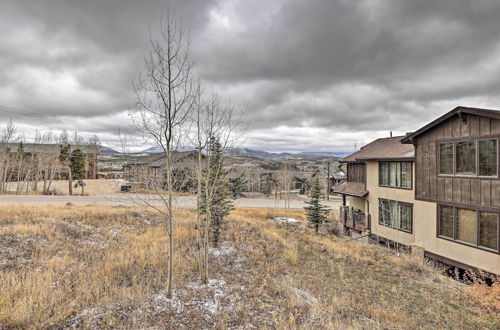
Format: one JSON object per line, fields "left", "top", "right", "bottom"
{"left": 0, "top": 194, "right": 340, "bottom": 209}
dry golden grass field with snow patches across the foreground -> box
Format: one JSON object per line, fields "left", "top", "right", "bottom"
{"left": 0, "top": 205, "right": 500, "bottom": 329}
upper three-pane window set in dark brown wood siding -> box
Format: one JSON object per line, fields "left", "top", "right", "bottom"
{"left": 439, "top": 139, "right": 498, "bottom": 176}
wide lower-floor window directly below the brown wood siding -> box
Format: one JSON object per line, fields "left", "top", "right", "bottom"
{"left": 438, "top": 205, "right": 500, "bottom": 252}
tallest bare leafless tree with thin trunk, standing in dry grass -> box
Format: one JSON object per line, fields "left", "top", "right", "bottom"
{"left": 133, "top": 12, "right": 197, "bottom": 297}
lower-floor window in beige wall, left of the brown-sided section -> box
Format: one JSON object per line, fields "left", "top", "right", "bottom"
{"left": 378, "top": 199, "right": 413, "bottom": 233}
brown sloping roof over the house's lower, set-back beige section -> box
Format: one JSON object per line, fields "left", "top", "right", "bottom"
{"left": 341, "top": 136, "right": 415, "bottom": 163}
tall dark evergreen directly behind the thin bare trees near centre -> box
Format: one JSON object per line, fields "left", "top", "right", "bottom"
{"left": 201, "top": 137, "right": 233, "bottom": 246}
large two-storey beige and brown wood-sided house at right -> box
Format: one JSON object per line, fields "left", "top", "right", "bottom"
{"left": 335, "top": 107, "right": 500, "bottom": 274}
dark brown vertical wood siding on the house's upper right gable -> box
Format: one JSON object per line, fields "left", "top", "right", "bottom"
{"left": 415, "top": 115, "right": 500, "bottom": 210}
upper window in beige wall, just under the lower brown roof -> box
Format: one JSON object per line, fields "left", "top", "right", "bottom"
{"left": 379, "top": 162, "right": 412, "bottom": 189}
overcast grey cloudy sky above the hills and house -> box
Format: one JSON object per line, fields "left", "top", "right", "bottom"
{"left": 0, "top": 0, "right": 500, "bottom": 151}
